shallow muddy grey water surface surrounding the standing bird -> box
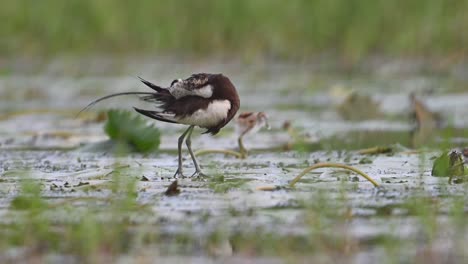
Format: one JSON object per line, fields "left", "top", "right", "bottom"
{"left": 0, "top": 59, "right": 468, "bottom": 263}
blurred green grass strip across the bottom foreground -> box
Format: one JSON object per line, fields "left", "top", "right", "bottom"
{"left": 0, "top": 170, "right": 468, "bottom": 263}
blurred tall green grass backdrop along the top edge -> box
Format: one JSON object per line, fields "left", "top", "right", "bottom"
{"left": 0, "top": 0, "right": 468, "bottom": 59}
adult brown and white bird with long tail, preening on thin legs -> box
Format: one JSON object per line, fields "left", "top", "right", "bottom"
{"left": 82, "top": 73, "right": 240, "bottom": 177}
